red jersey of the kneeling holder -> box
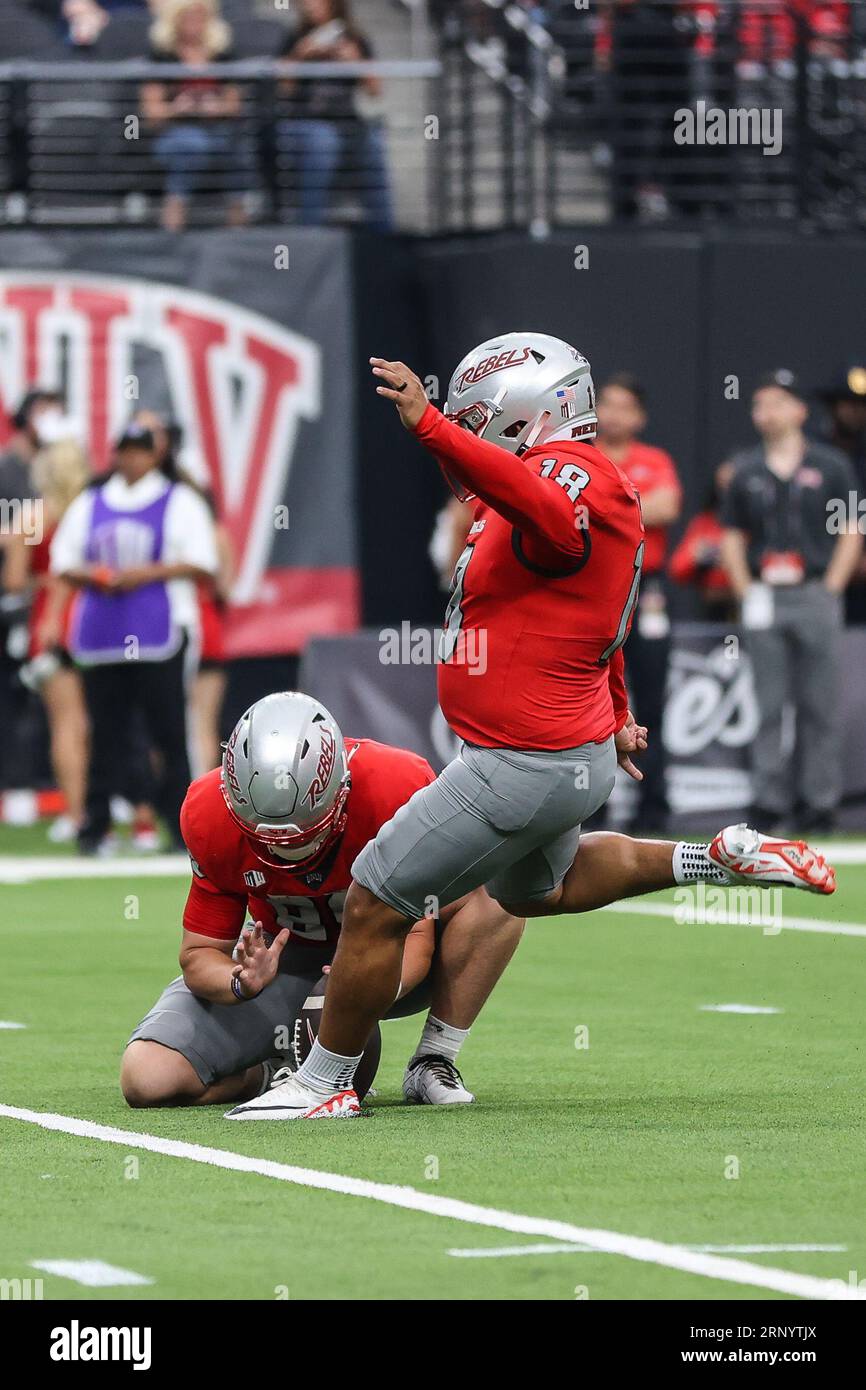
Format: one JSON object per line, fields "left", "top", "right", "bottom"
{"left": 181, "top": 738, "right": 435, "bottom": 942}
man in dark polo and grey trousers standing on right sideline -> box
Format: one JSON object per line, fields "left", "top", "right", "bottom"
{"left": 721, "top": 370, "right": 863, "bottom": 831}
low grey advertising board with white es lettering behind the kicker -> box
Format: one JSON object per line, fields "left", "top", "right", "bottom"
{"left": 300, "top": 623, "right": 866, "bottom": 824}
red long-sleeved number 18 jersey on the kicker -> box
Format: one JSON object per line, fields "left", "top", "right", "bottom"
{"left": 416, "top": 404, "right": 644, "bottom": 749}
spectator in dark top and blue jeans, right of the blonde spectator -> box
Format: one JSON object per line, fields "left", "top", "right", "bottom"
{"left": 278, "top": 0, "right": 393, "bottom": 231}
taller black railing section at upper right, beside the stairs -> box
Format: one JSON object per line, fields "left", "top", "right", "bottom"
{"left": 434, "top": 0, "right": 866, "bottom": 228}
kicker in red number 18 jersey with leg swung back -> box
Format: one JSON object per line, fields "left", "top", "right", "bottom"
{"left": 226, "top": 332, "right": 835, "bottom": 1119}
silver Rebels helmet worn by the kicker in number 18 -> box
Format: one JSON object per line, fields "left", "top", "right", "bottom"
{"left": 445, "top": 334, "right": 598, "bottom": 496}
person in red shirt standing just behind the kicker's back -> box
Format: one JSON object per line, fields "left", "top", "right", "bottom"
{"left": 596, "top": 371, "right": 683, "bottom": 831}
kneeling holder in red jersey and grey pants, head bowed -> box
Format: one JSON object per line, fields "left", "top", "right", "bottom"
{"left": 121, "top": 692, "right": 523, "bottom": 1119}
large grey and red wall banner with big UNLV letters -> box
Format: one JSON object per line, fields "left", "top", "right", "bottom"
{"left": 0, "top": 228, "right": 359, "bottom": 656}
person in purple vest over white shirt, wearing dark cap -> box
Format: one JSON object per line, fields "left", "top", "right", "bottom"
{"left": 51, "top": 424, "right": 218, "bottom": 853}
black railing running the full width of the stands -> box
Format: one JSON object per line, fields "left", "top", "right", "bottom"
{"left": 0, "top": 0, "right": 866, "bottom": 234}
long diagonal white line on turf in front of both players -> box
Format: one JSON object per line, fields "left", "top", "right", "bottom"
{"left": 0, "top": 1105, "right": 866, "bottom": 1301}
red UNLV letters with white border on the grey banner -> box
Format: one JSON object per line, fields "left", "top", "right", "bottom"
{"left": 0, "top": 271, "right": 321, "bottom": 605}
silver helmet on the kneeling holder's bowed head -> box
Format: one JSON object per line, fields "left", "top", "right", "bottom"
{"left": 220, "top": 691, "right": 350, "bottom": 867}
